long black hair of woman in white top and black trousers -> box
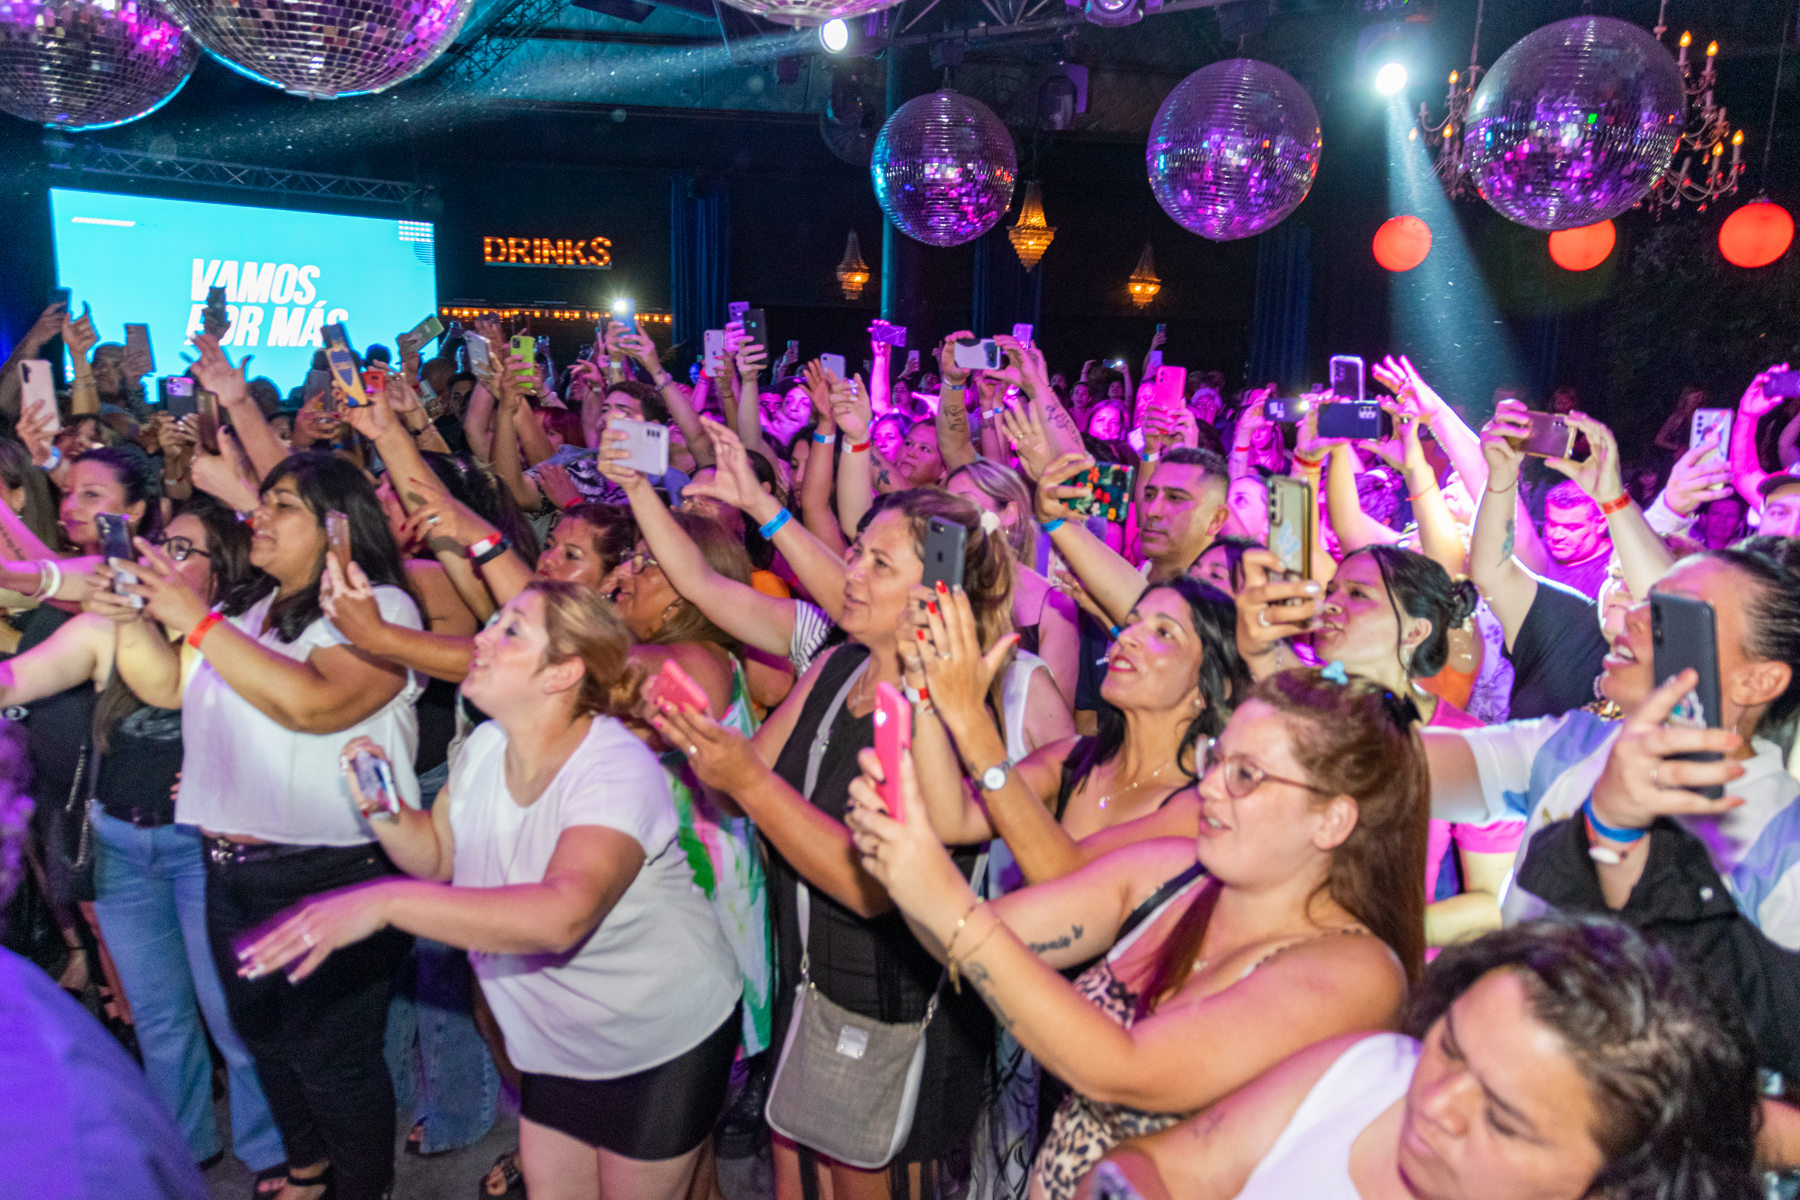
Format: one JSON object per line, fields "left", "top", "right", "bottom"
{"left": 221, "top": 450, "right": 425, "bottom": 642}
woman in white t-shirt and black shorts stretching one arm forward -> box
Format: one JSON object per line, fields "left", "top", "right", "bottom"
{"left": 241, "top": 581, "right": 740, "bottom": 1200}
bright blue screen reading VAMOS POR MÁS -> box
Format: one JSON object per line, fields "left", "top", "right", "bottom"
{"left": 50, "top": 187, "right": 437, "bottom": 396}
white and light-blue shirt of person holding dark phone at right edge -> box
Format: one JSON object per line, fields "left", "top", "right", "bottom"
{"left": 1456, "top": 709, "right": 1800, "bottom": 950}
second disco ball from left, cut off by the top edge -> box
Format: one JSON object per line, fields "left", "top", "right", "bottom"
{"left": 162, "top": 0, "right": 475, "bottom": 99}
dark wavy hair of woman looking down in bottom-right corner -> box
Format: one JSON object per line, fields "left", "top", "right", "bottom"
{"left": 1406, "top": 916, "right": 1762, "bottom": 1200}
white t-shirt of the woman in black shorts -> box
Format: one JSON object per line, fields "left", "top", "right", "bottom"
{"left": 448, "top": 716, "right": 743, "bottom": 1079}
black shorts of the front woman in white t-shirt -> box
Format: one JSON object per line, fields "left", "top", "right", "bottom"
{"left": 518, "top": 1004, "right": 743, "bottom": 1162}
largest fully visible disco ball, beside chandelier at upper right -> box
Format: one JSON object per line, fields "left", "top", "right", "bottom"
{"left": 1463, "top": 16, "right": 1687, "bottom": 230}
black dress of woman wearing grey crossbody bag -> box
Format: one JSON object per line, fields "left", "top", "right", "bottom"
{"left": 769, "top": 644, "right": 994, "bottom": 1162}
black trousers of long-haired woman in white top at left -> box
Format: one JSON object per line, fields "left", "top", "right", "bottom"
{"left": 207, "top": 844, "right": 412, "bottom": 1200}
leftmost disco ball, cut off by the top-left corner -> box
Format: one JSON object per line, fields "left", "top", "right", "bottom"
{"left": 0, "top": 0, "right": 200, "bottom": 130}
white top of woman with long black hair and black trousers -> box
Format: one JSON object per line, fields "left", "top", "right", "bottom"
{"left": 175, "top": 585, "right": 425, "bottom": 846}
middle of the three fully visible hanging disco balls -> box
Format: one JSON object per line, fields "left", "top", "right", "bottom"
{"left": 1143, "top": 58, "right": 1319, "bottom": 241}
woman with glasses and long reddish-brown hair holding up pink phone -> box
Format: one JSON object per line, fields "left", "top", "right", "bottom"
{"left": 850, "top": 671, "right": 1427, "bottom": 1200}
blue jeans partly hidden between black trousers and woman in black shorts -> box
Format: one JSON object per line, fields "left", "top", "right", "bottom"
{"left": 387, "top": 937, "right": 500, "bottom": 1155}
